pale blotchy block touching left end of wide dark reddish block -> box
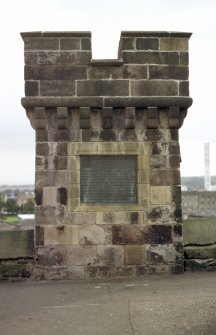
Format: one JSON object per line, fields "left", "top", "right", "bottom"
{"left": 79, "top": 225, "right": 111, "bottom": 245}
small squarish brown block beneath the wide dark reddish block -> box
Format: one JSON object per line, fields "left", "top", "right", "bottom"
{"left": 125, "top": 245, "right": 145, "bottom": 265}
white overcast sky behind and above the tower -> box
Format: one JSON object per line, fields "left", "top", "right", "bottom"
{"left": 0, "top": 0, "right": 216, "bottom": 185}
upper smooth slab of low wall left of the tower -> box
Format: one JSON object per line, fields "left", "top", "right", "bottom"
{"left": 0, "top": 230, "right": 34, "bottom": 259}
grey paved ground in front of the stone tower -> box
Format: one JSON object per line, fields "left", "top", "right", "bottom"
{"left": 0, "top": 273, "right": 216, "bottom": 335}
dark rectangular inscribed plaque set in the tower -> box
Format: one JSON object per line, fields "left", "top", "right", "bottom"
{"left": 80, "top": 155, "right": 137, "bottom": 204}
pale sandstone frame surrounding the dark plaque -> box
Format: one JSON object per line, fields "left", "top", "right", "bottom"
{"left": 68, "top": 142, "right": 150, "bottom": 212}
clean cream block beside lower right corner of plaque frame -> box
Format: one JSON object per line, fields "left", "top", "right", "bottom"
{"left": 150, "top": 186, "right": 172, "bottom": 205}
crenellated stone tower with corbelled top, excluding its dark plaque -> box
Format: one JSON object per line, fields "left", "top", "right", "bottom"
{"left": 21, "top": 32, "right": 192, "bottom": 279}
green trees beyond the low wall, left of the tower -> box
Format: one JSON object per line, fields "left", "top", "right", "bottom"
{"left": 0, "top": 195, "right": 35, "bottom": 214}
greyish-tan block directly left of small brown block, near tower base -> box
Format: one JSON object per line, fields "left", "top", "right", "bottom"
{"left": 97, "top": 245, "right": 124, "bottom": 265}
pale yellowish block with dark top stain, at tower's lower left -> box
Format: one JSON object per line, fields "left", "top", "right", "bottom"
{"left": 44, "top": 225, "right": 79, "bottom": 246}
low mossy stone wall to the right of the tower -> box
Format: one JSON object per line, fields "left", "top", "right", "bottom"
{"left": 183, "top": 218, "right": 216, "bottom": 271}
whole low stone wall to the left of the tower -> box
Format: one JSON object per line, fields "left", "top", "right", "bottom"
{"left": 0, "top": 229, "right": 34, "bottom": 280}
